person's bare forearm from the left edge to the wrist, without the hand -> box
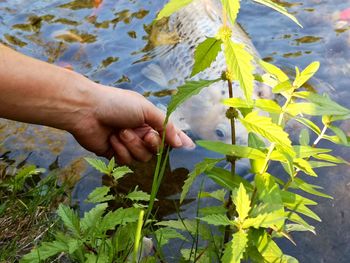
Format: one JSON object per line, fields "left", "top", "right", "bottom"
{"left": 0, "top": 45, "right": 93, "bottom": 133}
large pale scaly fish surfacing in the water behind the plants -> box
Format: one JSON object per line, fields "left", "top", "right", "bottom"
{"left": 141, "top": 0, "right": 273, "bottom": 145}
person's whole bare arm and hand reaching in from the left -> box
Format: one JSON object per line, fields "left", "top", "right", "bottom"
{"left": 0, "top": 44, "right": 194, "bottom": 164}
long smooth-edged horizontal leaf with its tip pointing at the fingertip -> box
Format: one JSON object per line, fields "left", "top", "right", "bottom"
{"left": 196, "top": 141, "right": 266, "bottom": 159}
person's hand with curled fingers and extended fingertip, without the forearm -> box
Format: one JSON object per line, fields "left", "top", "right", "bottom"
{"left": 70, "top": 84, "right": 194, "bottom": 164}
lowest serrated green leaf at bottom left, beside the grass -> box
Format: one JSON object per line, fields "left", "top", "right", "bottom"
{"left": 20, "top": 240, "right": 69, "bottom": 263}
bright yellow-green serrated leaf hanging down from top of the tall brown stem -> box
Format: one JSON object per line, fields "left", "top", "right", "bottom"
{"left": 224, "top": 39, "right": 254, "bottom": 102}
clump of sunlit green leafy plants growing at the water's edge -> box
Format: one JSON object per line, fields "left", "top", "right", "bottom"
{"left": 22, "top": 0, "right": 350, "bottom": 262}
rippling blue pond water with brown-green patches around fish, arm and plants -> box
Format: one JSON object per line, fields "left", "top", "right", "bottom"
{"left": 0, "top": 0, "right": 350, "bottom": 263}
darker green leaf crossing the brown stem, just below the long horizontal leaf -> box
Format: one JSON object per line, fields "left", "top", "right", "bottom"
{"left": 206, "top": 167, "right": 253, "bottom": 191}
